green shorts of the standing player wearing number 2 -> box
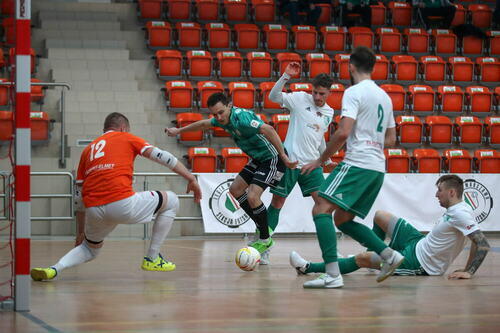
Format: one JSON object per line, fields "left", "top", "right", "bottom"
{"left": 319, "top": 162, "right": 384, "bottom": 219}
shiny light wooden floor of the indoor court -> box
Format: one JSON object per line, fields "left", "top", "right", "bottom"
{"left": 0, "top": 238, "right": 500, "bottom": 333}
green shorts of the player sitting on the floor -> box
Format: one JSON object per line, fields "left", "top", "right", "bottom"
{"left": 389, "top": 218, "right": 427, "bottom": 275}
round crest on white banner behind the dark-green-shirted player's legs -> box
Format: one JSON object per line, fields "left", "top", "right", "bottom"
{"left": 208, "top": 179, "right": 250, "bottom": 228}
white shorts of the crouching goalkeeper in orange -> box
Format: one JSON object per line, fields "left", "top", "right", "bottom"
{"left": 85, "top": 191, "right": 160, "bottom": 243}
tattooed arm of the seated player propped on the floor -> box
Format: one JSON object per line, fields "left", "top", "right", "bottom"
{"left": 448, "top": 230, "right": 490, "bottom": 279}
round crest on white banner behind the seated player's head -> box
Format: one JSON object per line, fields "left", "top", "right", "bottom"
{"left": 464, "top": 179, "right": 493, "bottom": 223}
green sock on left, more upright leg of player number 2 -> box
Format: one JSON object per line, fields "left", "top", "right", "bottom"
{"left": 313, "top": 214, "right": 337, "bottom": 263}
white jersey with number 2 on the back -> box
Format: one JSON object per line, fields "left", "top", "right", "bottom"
{"left": 342, "top": 80, "right": 396, "bottom": 172}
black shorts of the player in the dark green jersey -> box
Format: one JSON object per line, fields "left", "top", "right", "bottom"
{"left": 239, "top": 156, "right": 286, "bottom": 189}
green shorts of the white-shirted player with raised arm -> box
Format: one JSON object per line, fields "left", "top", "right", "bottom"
{"left": 271, "top": 168, "right": 325, "bottom": 198}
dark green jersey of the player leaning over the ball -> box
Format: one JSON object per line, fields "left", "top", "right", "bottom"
{"left": 211, "top": 106, "right": 278, "bottom": 161}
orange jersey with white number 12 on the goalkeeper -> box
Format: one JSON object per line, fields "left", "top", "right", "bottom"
{"left": 77, "top": 131, "right": 152, "bottom": 207}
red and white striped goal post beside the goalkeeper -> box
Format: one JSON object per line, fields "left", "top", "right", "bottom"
{"left": 14, "top": 0, "right": 31, "bottom": 311}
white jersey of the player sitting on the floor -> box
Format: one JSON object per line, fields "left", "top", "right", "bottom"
{"left": 415, "top": 201, "right": 479, "bottom": 275}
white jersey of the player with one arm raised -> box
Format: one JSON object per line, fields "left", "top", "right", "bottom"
{"left": 282, "top": 91, "right": 333, "bottom": 168}
